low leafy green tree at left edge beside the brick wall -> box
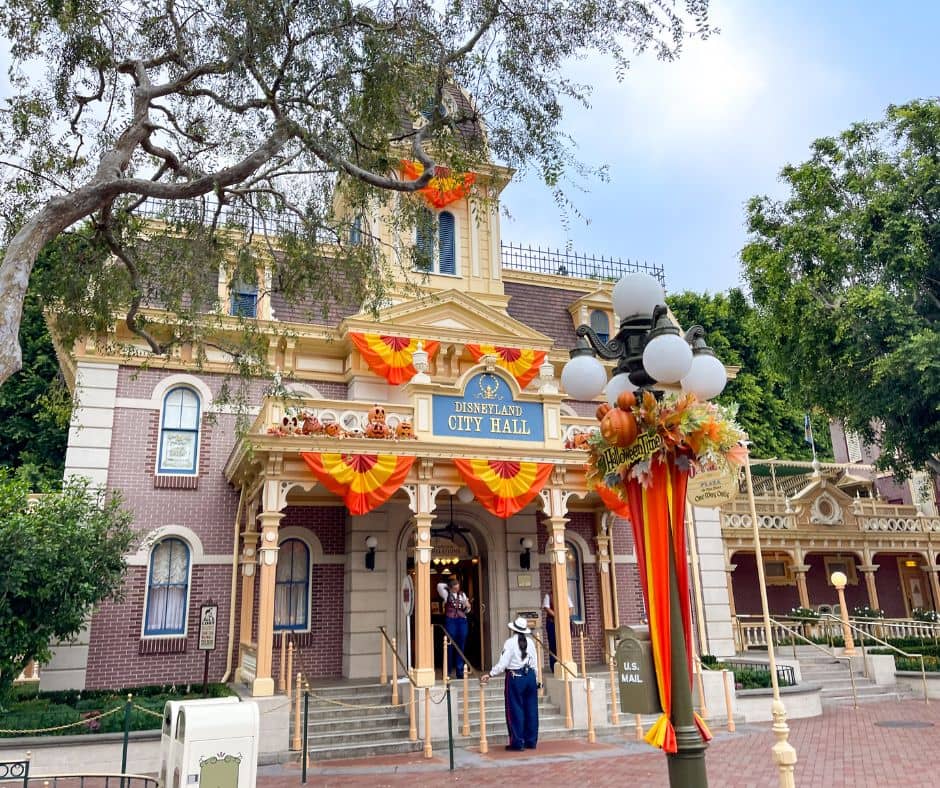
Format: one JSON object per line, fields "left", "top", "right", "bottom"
{"left": 0, "top": 471, "right": 135, "bottom": 698}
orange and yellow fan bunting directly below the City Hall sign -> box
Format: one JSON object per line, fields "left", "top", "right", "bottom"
{"left": 454, "top": 460, "right": 554, "bottom": 519}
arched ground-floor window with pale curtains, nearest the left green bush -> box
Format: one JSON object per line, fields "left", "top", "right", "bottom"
{"left": 144, "top": 538, "right": 189, "bottom": 635}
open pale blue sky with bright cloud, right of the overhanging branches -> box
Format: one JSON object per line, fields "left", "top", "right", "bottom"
{"left": 502, "top": 0, "right": 940, "bottom": 292}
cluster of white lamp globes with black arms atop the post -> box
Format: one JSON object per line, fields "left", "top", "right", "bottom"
{"left": 561, "top": 272, "right": 728, "bottom": 406}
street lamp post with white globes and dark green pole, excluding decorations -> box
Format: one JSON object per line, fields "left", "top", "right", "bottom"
{"left": 561, "top": 273, "right": 727, "bottom": 788}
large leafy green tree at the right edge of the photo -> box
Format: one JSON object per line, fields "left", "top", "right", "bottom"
{"left": 742, "top": 100, "right": 940, "bottom": 475}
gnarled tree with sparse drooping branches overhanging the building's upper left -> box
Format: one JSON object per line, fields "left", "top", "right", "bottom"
{"left": 0, "top": 0, "right": 710, "bottom": 381}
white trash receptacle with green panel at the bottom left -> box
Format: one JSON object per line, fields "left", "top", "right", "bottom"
{"left": 167, "top": 703, "right": 260, "bottom": 788}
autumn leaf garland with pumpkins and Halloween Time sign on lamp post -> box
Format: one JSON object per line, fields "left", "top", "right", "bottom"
{"left": 587, "top": 391, "right": 747, "bottom": 500}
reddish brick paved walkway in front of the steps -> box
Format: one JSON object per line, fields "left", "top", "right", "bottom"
{"left": 258, "top": 701, "right": 940, "bottom": 788}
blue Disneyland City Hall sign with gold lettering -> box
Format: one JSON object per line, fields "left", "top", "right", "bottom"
{"left": 433, "top": 372, "right": 545, "bottom": 442}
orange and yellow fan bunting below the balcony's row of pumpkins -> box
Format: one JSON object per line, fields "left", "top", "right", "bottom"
{"left": 300, "top": 451, "right": 415, "bottom": 515}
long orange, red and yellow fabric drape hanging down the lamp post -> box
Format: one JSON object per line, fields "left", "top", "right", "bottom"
{"left": 626, "top": 455, "right": 711, "bottom": 753}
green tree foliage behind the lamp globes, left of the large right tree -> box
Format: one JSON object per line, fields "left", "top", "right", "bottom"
{"left": 666, "top": 288, "right": 831, "bottom": 460}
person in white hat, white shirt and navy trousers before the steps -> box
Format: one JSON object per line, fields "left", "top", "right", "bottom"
{"left": 480, "top": 616, "right": 539, "bottom": 750}
